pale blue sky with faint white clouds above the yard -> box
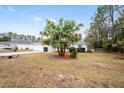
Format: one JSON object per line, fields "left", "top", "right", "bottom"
{"left": 0, "top": 5, "right": 97, "bottom": 36}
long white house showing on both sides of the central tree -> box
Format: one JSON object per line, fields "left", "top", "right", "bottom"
{"left": 0, "top": 34, "right": 87, "bottom": 52}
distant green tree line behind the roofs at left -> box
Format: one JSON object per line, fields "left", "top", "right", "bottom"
{"left": 0, "top": 32, "right": 40, "bottom": 42}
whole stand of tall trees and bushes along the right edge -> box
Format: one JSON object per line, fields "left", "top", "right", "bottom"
{"left": 86, "top": 5, "right": 124, "bottom": 52}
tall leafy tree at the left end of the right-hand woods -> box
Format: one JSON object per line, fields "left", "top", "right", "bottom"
{"left": 87, "top": 6, "right": 108, "bottom": 48}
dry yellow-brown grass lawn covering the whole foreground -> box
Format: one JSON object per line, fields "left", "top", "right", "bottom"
{"left": 0, "top": 53, "right": 124, "bottom": 87}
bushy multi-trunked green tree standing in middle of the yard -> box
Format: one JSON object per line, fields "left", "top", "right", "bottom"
{"left": 40, "top": 18, "right": 83, "bottom": 56}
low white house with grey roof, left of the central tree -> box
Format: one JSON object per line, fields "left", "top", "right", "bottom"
{"left": 0, "top": 39, "right": 54, "bottom": 52}
